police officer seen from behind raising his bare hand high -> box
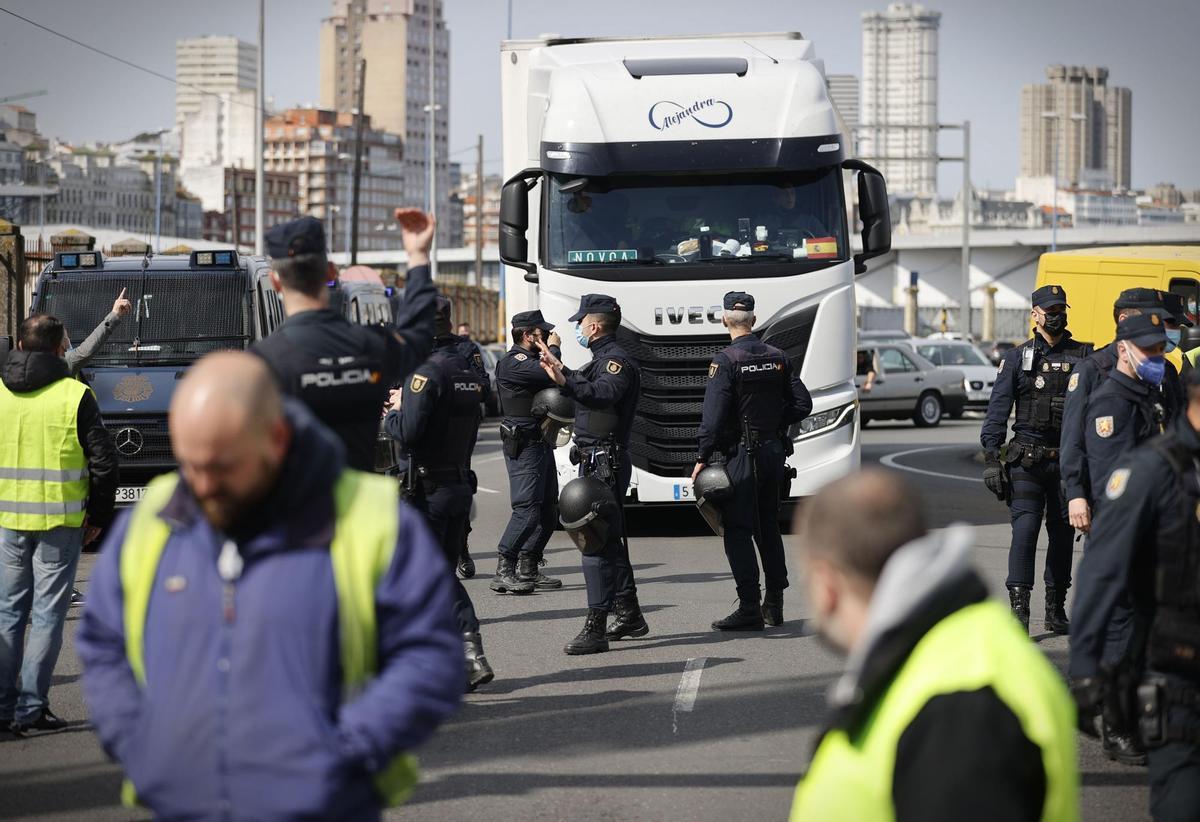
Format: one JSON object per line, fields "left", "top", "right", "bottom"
{"left": 254, "top": 209, "right": 437, "bottom": 470}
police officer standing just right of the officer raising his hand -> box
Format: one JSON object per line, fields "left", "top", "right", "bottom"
{"left": 384, "top": 296, "right": 494, "bottom": 690}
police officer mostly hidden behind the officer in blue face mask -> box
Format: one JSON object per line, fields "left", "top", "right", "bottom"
{"left": 1061, "top": 288, "right": 1182, "bottom": 533}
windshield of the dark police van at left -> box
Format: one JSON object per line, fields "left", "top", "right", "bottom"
{"left": 38, "top": 270, "right": 250, "bottom": 366}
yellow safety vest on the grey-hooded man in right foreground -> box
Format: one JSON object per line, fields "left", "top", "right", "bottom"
{"left": 791, "top": 601, "right": 1079, "bottom": 822}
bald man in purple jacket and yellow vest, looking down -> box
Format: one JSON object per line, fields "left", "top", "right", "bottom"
{"left": 78, "top": 352, "right": 464, "bottom": 820}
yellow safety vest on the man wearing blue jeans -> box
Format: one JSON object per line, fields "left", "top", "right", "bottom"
{"left": 0, "top": 377, "right": 91, "bottom": 530}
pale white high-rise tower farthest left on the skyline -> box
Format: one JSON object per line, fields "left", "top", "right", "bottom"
{"left": 175, "top": 36, "right": 258, "bottom": 125}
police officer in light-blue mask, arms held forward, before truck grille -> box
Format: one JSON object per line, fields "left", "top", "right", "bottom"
{"left": 539, "top": 294, "right": 650, "bottom": 654}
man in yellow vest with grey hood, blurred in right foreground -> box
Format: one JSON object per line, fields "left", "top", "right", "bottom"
{"left": 791, "top": 470, "right": 1079, "bottom": 822}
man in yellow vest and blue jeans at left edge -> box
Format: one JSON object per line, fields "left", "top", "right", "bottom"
{"left": 0, "top": 314, "right": 116, "bottom": 734}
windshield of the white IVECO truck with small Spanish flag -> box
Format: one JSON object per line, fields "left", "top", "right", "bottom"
{"left": 547, "top": 167, "right": 850, "bottom": 269}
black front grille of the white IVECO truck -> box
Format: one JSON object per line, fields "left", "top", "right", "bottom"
{"left": 617, "top": 306, "right": 816, "bottom": 476}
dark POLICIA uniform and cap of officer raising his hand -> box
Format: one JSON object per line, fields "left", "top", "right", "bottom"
{"left": 252, "top": 217, "right": 437, "bottom": 470}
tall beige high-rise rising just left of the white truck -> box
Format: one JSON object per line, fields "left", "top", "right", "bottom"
{"left": 320, "top": 0, "right": 454, "bottom": 246}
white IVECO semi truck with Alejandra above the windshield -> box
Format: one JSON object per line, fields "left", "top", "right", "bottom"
{"left": 500, "top": 34, "right": 890, "bottom": 503}
